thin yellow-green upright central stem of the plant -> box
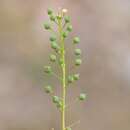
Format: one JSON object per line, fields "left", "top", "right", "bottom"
{"left": 58, "top": 19, "right": 66, "bottom": 130}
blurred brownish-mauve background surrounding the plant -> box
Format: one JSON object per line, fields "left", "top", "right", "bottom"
{"left": 0, "top": 0, "right": 130, "bottom": 130}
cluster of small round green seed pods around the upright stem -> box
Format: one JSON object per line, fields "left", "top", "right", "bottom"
{"left": 44, "top": 9, "right": 86, "bottom": 130}
